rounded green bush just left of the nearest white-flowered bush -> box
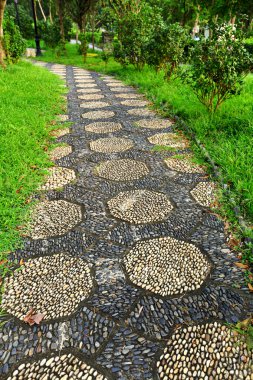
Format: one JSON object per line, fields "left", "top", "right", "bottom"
{"left": 147, "top": 23, "right": 189, "bottom": 79}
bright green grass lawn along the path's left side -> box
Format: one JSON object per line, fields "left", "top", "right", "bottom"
{"left": 0, "top": 63, "right": 65, "bottom": 255}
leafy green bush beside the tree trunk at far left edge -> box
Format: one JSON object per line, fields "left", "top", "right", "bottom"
{"left": 3, "top": 17, "right": 26, "bottom": 63}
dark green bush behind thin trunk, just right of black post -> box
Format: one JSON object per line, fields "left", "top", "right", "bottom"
{"left": 39, "top": 17, "right": 72, "bottom": 48}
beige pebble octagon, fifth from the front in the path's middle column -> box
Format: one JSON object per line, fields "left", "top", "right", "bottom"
{"left": 90, "top": 137, "right": 134, "bottom": 153}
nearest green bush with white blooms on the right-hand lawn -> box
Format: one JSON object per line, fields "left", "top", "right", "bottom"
{"left": 184, "top": 24, "right": 253, "bottom": 112}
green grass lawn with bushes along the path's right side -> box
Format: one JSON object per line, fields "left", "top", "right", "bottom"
{"left": 35, "top": 44, "right": 253, "bottom": 233}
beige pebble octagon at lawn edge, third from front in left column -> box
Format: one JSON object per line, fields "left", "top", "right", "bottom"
{"left": 29, "top": 200, "right": 82, "bottom": 239}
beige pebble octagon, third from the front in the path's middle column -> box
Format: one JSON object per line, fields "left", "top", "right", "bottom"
{"left": 107, "top": 190, "right": 173, "bottom": 224}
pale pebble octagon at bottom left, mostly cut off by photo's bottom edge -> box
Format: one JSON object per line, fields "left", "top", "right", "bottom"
{"left": 7, "top": 354, "right": 107, "bottom": 380}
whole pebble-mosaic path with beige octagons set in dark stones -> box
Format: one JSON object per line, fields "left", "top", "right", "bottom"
{"left": 0, "top": 63, "right": 253, "bottom": 380}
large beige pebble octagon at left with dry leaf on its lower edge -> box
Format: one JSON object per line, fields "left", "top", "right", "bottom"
{"left": 2, "top": 253, "right": 93, "bottom": 320}
